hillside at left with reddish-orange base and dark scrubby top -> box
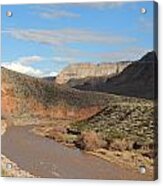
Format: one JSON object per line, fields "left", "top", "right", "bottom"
{"left": 1, "top": 68, "right": 111, "bottom": 121}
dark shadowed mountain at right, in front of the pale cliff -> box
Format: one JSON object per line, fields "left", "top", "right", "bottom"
{"left": 68, "top": 51, "right": 158, "bottom": 99}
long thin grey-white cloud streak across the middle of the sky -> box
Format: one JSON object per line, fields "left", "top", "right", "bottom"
{"left": 5, "top": 29, "right": 137, "bottom": 47}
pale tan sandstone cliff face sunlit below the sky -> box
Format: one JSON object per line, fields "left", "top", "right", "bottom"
{"left": 56, "top": 62, "right": 130, "bottom": 84}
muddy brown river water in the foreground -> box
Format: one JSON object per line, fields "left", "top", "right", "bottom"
{"left": 1, "top": 126, "right": 150, "bottom": 180}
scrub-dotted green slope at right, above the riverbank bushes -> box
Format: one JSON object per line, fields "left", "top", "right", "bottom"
{"left": 72, "top": 100, "right": 157, "bottom": 150}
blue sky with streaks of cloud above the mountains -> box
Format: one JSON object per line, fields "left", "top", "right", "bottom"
{"left": 2, "top": 1, "right": 153, "bottom": 76}
